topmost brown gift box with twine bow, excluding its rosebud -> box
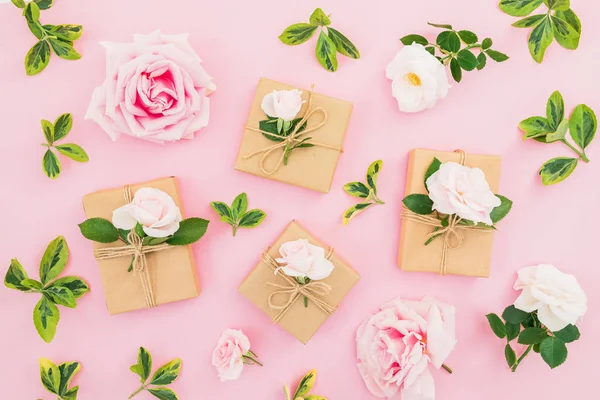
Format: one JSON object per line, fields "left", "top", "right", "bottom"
{"left": 235, "top": 78, "right": 353, "bottom": 193}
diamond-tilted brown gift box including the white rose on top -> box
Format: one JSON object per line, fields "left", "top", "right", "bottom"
{"left": 238, "top": 221, "right": 360, "bottom": 344}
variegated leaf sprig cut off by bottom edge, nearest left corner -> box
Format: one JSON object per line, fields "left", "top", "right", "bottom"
{"left": 40, "top": 358, "right": 81, "bottom": 400}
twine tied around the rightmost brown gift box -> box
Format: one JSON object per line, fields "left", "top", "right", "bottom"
{"left": 400, "top": 150, "right": 491, "bottom": 276}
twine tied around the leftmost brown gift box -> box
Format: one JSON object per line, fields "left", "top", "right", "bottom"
{"left": 95, "top": 186, "right": 170, "bottom": 308}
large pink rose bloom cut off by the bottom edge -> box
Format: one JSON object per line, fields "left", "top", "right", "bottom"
{"left": 356, "top": 296, "right": 456, "bottom": 400}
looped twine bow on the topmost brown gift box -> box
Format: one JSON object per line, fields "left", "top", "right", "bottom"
{"left": 242, "top": 85, "right": 343, "bottom": 175}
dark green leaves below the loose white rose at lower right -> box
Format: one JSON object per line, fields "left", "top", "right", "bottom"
{"left": 486, "top": 306, "right": 581, "bottom": 372}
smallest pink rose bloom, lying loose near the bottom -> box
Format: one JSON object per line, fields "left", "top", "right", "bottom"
{"left": 212, "top": 329, "right": 250, "bottom": 382}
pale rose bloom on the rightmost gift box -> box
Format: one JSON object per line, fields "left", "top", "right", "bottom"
{"left": 427, "top": 162, "right": 501, "bottom": 225}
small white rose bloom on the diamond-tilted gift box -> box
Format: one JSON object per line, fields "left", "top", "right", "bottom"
{"left": 276, "top": 239, "right": 334, "bottom": 281}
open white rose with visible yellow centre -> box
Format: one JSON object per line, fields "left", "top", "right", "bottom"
{"left": 385, "top": 43, "right": 450, "bottom": 113}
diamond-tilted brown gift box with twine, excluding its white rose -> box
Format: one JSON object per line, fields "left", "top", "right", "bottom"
{"left": 238, "top": 221, "right": 360, "bottom": 344}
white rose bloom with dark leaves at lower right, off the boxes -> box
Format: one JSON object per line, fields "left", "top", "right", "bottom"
{"left": 514, "top": 264, "right": 587, "bottom": 332}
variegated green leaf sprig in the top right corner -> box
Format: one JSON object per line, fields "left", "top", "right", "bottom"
{"left": 500, "top": 0, "right": 581, "bottom": 63}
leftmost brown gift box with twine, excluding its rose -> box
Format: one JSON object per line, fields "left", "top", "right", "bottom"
{"left": 80, "top": 177, "right": 207, "bottom": 314}
